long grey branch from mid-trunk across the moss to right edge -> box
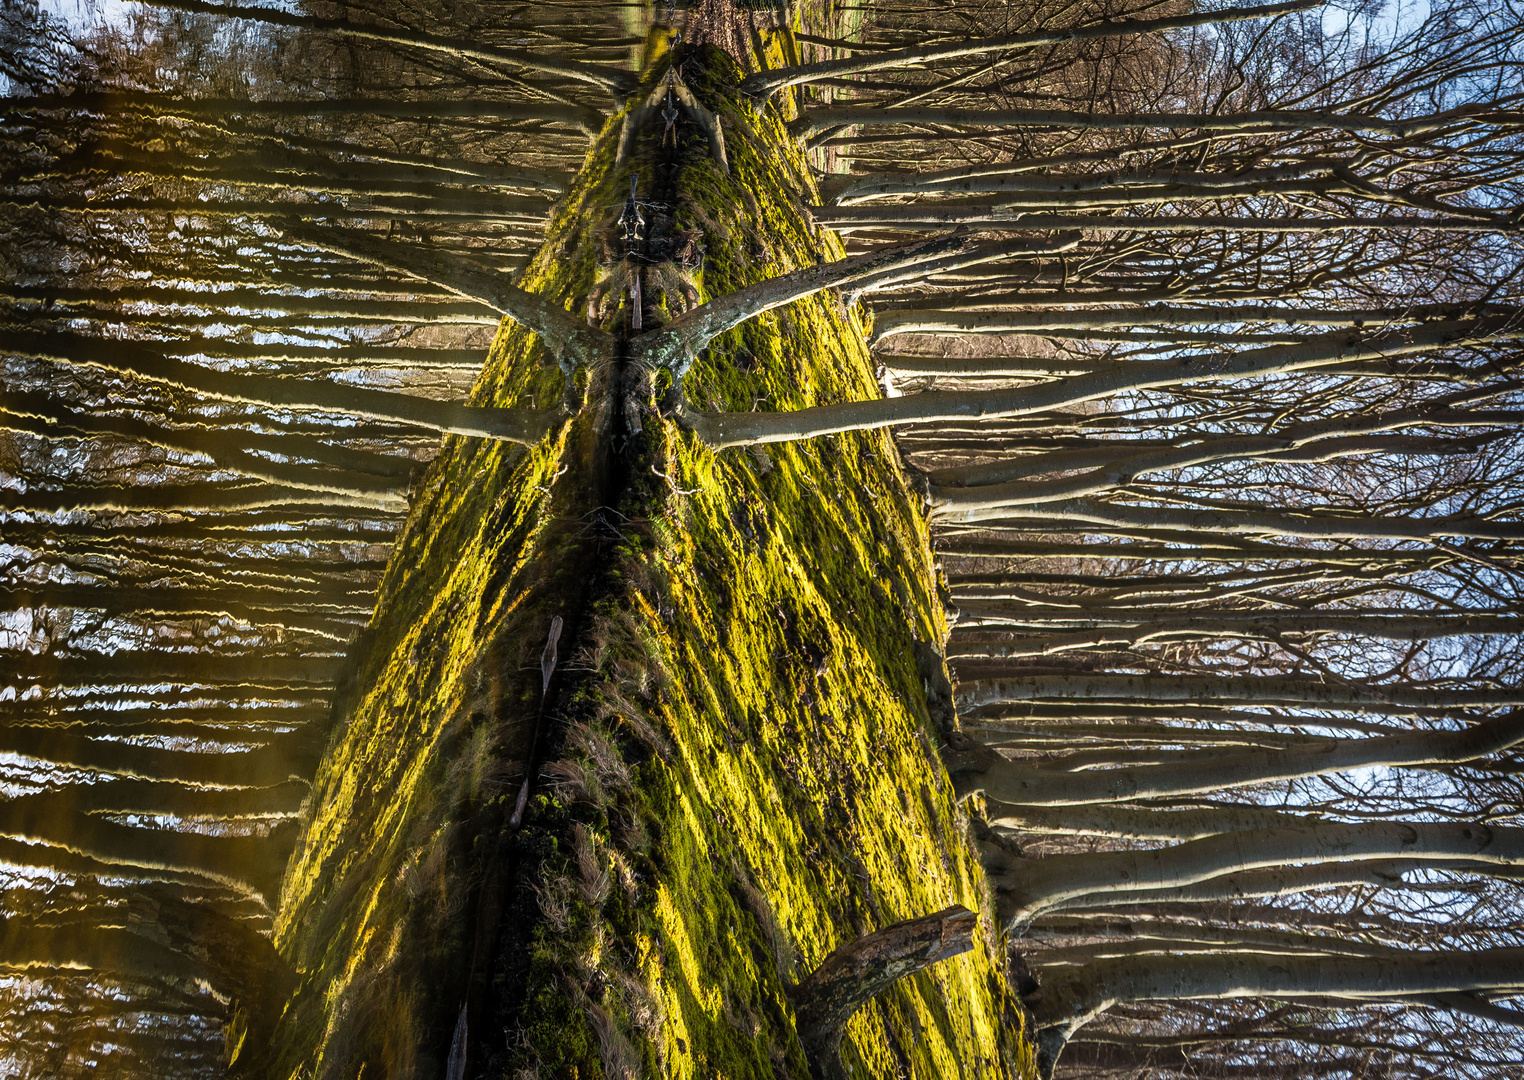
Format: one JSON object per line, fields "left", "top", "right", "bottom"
{"left": 677, "top": 311, "right": 1524, "bottom": 447}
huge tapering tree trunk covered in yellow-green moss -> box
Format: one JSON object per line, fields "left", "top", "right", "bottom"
{"left": 270, "top": 24, "right": 1030, "bottom": 1078}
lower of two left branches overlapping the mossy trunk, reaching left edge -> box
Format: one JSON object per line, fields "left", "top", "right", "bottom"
{"left": 0, "top": 331, "right": 556, "bottom": 447}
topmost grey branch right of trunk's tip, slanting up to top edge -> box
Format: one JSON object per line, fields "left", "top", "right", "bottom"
{"left": 741, "top": 0, "right": 1318, "bottom": 101}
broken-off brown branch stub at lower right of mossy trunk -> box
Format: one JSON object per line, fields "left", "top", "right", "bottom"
{"left": 789, "top": 903, "right": 978, "bottom": 1080}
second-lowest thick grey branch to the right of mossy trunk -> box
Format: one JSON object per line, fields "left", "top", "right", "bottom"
{"left": 1000, "top": 821, "right": 1524, "bottom": 929}
